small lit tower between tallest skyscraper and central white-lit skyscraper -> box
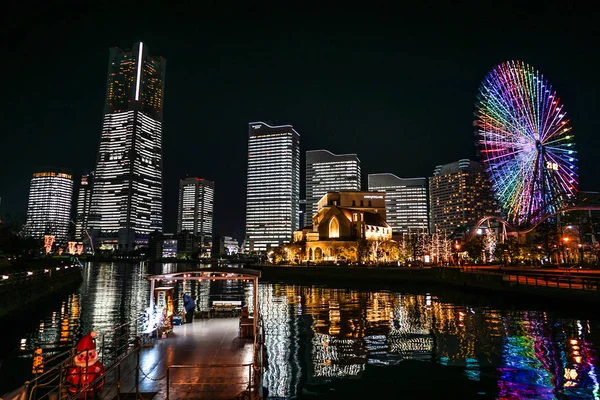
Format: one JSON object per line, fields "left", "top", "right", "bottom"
{"left": 177, "top": 178, "right": 215, "bottom": 243}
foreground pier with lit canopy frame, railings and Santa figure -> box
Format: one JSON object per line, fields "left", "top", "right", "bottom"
{"left": 2, "top": 268, "right": 264, "bottom": 400}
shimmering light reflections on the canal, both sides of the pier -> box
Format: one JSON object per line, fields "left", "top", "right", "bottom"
{"left": 7, "top": 263, "right": 600, "bottom": 399}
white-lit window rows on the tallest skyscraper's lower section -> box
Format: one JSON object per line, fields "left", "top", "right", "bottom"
{"left": 89, "top": 110, "right": 162, "bottom": 235}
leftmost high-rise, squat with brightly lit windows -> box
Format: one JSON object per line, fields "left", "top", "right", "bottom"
{"left": 25, "top": 171, "right": 73, "bottom": 242}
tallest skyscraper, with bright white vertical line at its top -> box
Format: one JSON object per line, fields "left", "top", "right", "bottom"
{"left": 89, "top": 42, "right": 166, "bottom": 251}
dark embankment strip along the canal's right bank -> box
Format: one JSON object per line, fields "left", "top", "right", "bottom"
{"left": 252, "top": 265, "right": 600, "bottom": 303}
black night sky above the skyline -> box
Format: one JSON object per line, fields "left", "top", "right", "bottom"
{"left": 0, "top": 1, "right": 600, "bottom": 240}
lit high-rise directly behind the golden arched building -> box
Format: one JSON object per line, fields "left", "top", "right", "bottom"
{"left": 304, "top": 150, "right": 361, "bottom": 225}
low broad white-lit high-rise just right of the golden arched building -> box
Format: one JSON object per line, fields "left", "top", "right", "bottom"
{"left": 368, "top": 174, "right": 429, "bottom": 235}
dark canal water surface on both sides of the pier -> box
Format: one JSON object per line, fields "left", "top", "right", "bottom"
{"left": 0, "top": 263, "right": 600, "bottom": 399}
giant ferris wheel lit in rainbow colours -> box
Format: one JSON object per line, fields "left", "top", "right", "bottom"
{"left": 475, "top": 61, "right": 578, "bottom": 227}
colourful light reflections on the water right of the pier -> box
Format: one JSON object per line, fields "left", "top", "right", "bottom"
{"left": 260, "top": 285, "right": 599, "bottom": 399}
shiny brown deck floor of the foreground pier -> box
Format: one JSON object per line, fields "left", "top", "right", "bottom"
{"left": 99, "top": 318, "right": 254, "bottom": 399}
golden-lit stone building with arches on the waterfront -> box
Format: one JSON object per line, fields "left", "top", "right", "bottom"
{"left": 294, "top": 191, "right": 392, "bottom": 262}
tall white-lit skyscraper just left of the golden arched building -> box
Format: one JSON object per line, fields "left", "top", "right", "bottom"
{"left": 245, "top": 122, "right": 300, "bottom": 251}
